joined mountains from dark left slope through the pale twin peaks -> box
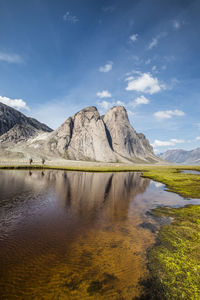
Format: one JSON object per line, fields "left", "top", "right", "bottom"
{"left": 0, "top": 103, "right": 160, "bottom": 163}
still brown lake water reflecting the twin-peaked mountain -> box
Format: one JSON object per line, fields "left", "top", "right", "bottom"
{"left": 0, "top": 170, "right": 199, "bottom": 299}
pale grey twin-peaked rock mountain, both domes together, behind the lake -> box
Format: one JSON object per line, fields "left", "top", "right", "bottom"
{"left": 43, "top": 106, "right": 158, "bottom": 162}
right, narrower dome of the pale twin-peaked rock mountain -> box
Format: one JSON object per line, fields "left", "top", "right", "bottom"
{"left": 103, "top": 106, "right": 156, "bottom": 160}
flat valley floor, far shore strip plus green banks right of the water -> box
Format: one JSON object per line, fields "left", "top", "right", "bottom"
{"left": 0, "top": 161, "right": 200, "bottom": 299}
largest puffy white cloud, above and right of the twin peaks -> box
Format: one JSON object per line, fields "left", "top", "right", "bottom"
{"left": 126, "top": 73, "right": 165, "bottom": 94}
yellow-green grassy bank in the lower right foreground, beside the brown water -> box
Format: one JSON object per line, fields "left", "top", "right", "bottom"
{"left": 148, "top": 205, "right": 200, "bottom": 300}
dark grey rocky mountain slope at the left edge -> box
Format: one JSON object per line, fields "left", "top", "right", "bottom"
{"left": 0, "top": 102, "right": 52, "bottom": 143}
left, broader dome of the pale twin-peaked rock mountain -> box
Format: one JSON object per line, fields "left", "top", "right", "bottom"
{"left": 48, "top": 106, "right": 116, "bottom": 162}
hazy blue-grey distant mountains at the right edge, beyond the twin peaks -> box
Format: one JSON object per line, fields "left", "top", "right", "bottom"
{"left": 158, "top": 148, "right": 200, "bottom": 165}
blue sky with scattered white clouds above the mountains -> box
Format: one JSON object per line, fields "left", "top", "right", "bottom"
{"left": 0, "top": 0, "right": 200, "bottom": 153}
